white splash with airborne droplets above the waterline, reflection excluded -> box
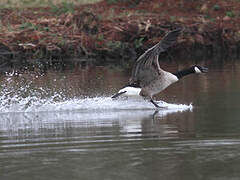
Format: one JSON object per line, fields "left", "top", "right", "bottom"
{"left": 0, "top": 72, "right": 192, "bottom": 113}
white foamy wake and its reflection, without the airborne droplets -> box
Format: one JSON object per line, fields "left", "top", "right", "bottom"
{"left": 0, "top": 97, "right": 192, "bottom": 135}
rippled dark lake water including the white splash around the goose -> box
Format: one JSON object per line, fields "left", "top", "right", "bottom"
{"left": 0, "top": 60, "right": 240, "bottom": 180}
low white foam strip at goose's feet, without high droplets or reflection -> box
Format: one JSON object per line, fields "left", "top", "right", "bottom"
{"left": 0, "top": 94, "right": 192, "bottom": 113}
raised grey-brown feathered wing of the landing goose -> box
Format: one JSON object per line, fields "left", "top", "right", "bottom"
{"left": 130, "top": 28, "right": 182, "bottom": 87}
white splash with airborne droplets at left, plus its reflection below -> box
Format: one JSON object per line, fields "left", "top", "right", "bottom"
{"left": 0, "top": 72, "right": 192, "bottom": 134}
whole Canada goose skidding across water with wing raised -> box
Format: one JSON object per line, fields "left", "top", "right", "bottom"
{"left": 112, "top": 28, "right": 208, "bottom": 107}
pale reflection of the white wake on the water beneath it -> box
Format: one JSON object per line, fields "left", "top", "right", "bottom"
{"left": 0, "top": 105, "right": 191, "bottom": 136}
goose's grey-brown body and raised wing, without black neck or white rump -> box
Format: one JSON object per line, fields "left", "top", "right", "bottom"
{"left": 129, "top": 28, "right": 181, "bottom": 98}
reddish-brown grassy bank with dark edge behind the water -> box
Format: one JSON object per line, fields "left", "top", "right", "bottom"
{"left": 0, "top": 0, "right": 240, "bottom": 71}
